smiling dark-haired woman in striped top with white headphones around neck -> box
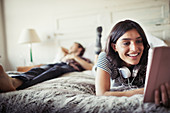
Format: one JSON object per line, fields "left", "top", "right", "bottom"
{"left": 95, "top": 20, "right": 169, "bottom": 106}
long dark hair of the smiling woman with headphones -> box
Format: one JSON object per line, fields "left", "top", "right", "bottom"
{"left": 105, "top": 20, "right": 150, "bottom": 67}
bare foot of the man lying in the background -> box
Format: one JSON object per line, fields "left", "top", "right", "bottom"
{"left": 0, "top": 65, "right": 16, "bottom": 92}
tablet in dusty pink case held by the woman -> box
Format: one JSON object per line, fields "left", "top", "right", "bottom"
{"left": 143, "top": 47, "right": 170, "bottom": 102}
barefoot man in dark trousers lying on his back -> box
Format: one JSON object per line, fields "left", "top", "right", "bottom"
{"left": 0, "top": 42, "right": 93, "bottom": 92}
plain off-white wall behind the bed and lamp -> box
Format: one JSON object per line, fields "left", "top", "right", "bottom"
{"left": 4, "top": 0, "right": 170, "bottom": 70}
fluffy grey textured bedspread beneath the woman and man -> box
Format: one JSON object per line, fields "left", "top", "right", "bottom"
{"left": 0, "top": 72, "right": 170, "bottom": 113}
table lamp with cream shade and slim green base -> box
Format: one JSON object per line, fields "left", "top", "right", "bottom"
{"left": 18, "top": 29, "right": 40, "bottom": 63}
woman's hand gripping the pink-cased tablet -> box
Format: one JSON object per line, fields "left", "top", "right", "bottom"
{"left": 155, "top": 82, "right": 170, "bottom": 108}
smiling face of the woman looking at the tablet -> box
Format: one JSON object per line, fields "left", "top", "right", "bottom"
{"left": 112, "top": 29, "right": 144, "bottom": 66}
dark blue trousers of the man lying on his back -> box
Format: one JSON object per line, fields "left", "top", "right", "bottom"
{"left": 12, "top": 63, "right": 77, "bottom": 89}
